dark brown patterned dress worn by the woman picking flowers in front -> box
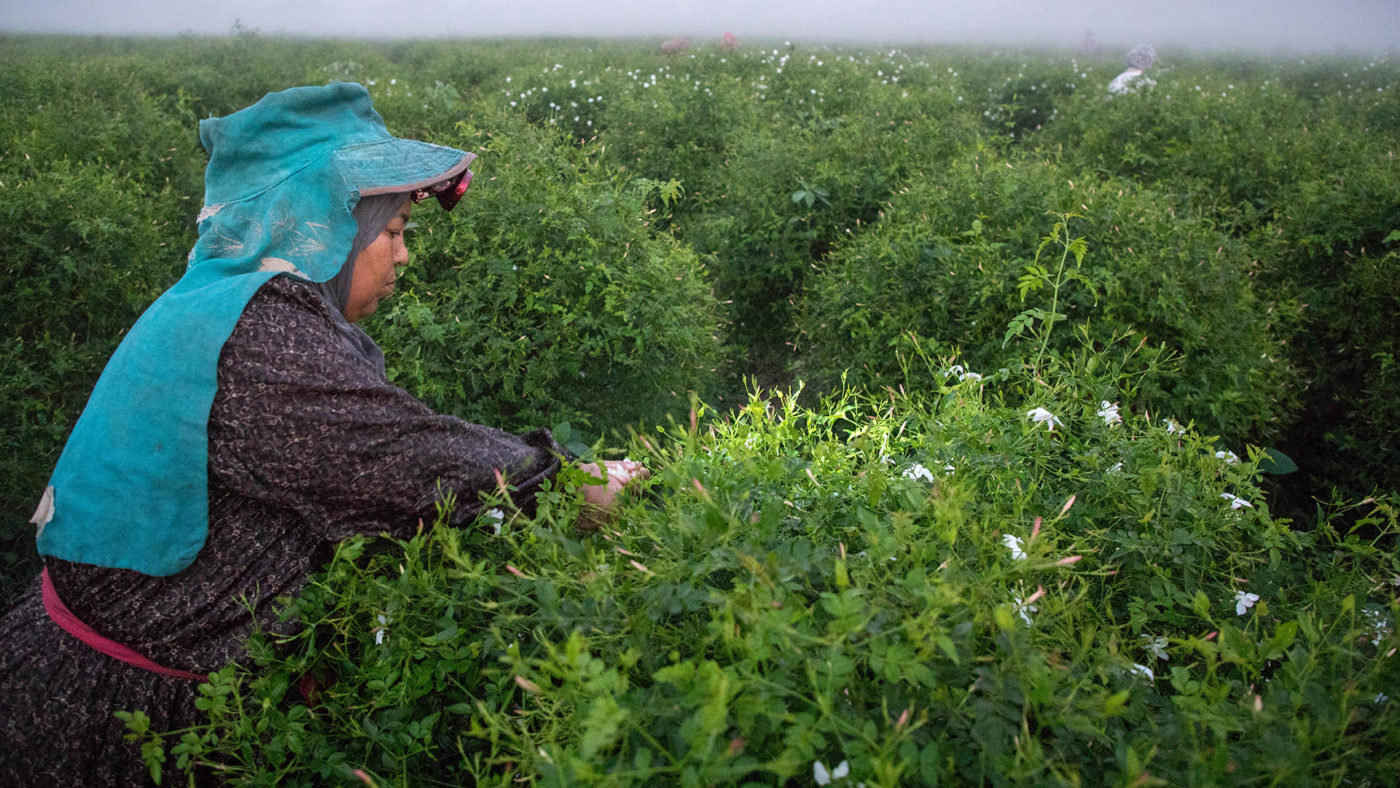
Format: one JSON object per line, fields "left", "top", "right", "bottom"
{"left": 0, "top": 277, "right": 564, "bottom": 785}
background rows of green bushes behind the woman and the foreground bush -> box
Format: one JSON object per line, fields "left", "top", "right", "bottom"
{"left": 0, "top": 31, "right": 1400, "bottom": 604}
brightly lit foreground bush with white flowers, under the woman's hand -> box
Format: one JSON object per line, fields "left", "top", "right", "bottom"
{"left": 123, "top": 368, "right": 1400, "bottom": 785}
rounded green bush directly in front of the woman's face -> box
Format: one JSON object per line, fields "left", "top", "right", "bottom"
{"left": 370, "top": 107, "right": 720, "bottom": 428}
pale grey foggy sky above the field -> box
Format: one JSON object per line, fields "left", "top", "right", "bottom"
{"left": 0, "top": 0, "right": 1400, "bottom": 53}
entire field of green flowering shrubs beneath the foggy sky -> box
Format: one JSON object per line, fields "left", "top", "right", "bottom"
{"left": 0, "top": 29, "right": 1400, "bottom": 785}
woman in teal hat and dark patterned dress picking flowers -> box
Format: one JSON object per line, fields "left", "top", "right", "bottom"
{"left": 0, "top": 84, "right": 645, "bottom": 785}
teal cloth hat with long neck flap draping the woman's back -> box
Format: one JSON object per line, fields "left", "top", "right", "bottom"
{"left": 35, "top": 83, "right": 475, "bottom": 575}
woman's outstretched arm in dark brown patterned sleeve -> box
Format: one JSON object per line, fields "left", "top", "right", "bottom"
{"left": 209, "top": 277, "right": 564, "bottom": 539}
